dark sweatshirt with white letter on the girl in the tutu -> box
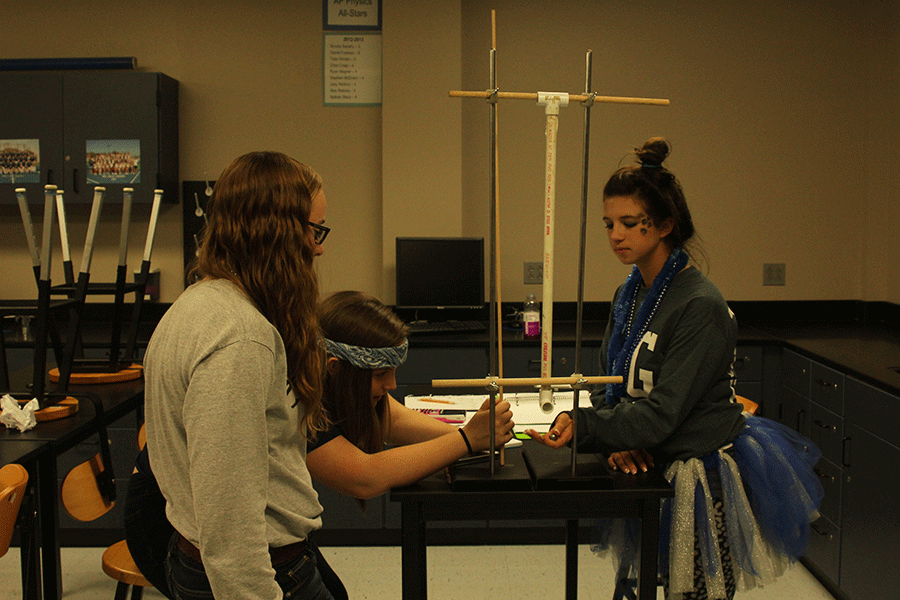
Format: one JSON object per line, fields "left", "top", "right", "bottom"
{"left": 577, "top": 267, "right": 744, "bottom": 464}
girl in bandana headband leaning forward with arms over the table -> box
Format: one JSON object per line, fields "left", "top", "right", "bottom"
{"left": 307, "top": 291, "right": 513, "bottom": 501}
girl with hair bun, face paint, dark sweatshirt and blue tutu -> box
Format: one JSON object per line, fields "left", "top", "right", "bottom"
{"left": 528, "top": 138, "right": 823, "bottom": 599}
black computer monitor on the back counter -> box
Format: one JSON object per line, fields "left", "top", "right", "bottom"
{"left": 397, "top": 237, "right": 484, "bottom": 309}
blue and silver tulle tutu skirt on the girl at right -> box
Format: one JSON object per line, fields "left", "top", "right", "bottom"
{"left": 592, "top": 415, "right": 824, "bottom": 598}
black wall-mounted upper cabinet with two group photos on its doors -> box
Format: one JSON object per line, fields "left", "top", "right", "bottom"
{"left": 0, "top": 71, "right": 178, "bottom": 204}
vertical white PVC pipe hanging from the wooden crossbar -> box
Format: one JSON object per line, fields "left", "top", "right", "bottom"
{"left": 537, "top": 92, "right": 569, "bottom": 413}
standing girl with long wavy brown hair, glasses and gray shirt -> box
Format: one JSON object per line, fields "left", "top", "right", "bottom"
{"left": 144, "top": 152, "right": 332, "bottom": 600}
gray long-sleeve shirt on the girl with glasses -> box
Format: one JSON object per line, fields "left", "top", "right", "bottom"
{"left": 144, "top": 280, "right": 322, "bottom": 600}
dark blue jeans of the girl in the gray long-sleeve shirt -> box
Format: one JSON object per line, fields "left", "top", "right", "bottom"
{"left": 166, "top": 537, "right": 333, "bottom": 600}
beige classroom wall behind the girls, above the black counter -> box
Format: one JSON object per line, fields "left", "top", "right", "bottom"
{"left": 0, "top": 0, "right": 900, "bottom": 310}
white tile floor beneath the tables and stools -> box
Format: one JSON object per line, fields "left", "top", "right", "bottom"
{"left": 0, "top": 546, "right": 833, "bottom": 600}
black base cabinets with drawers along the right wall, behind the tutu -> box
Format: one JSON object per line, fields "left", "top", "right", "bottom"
{"left": 778, "top": 349, "right": 900, "bottom": 600}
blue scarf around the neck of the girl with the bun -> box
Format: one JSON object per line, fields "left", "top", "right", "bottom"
{"left": 606, "top": 248, "right": 688, "bottom": 406}
